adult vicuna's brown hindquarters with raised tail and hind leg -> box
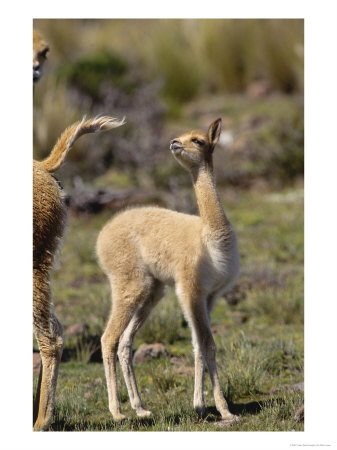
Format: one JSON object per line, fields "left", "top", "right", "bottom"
{"left": 33, "top": 117, "right": 124, "bottom": 430}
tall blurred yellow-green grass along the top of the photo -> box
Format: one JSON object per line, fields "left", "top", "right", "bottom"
{"left": 34, "top": 19, "right": 304, "bottom": 100}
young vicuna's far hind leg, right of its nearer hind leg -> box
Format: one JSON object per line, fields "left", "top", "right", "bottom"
{"left": 118, "top": 281, "right": 163, "bottom": 417}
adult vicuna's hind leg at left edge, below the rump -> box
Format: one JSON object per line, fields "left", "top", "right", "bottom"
{"left": 33, "top": 269, "right": 63, "bottom": 431}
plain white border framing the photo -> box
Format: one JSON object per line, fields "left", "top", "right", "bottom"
{"left": 0, "top": 0, "right": 337, "bottom": 450}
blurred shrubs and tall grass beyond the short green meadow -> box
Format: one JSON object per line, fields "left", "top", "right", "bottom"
{"left": 34, "top": 19, "right": 304, "bottom": 209}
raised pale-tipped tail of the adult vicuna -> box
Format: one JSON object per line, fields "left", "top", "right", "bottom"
{"left": 41, "top": 116, "right": 125, "bottom": 172}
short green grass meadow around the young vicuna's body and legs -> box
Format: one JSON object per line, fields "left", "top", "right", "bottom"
{"left": 34, "top": 181, "right": 304, "bottom": 431}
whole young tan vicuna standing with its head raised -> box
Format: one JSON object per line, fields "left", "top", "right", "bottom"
{"left": 97, "top": 119, "right": 239, "bottom": 420}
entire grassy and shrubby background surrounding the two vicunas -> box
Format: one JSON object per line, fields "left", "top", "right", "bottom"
{"left": 33, "top": 19, "right": 304, "bottom": 431}
